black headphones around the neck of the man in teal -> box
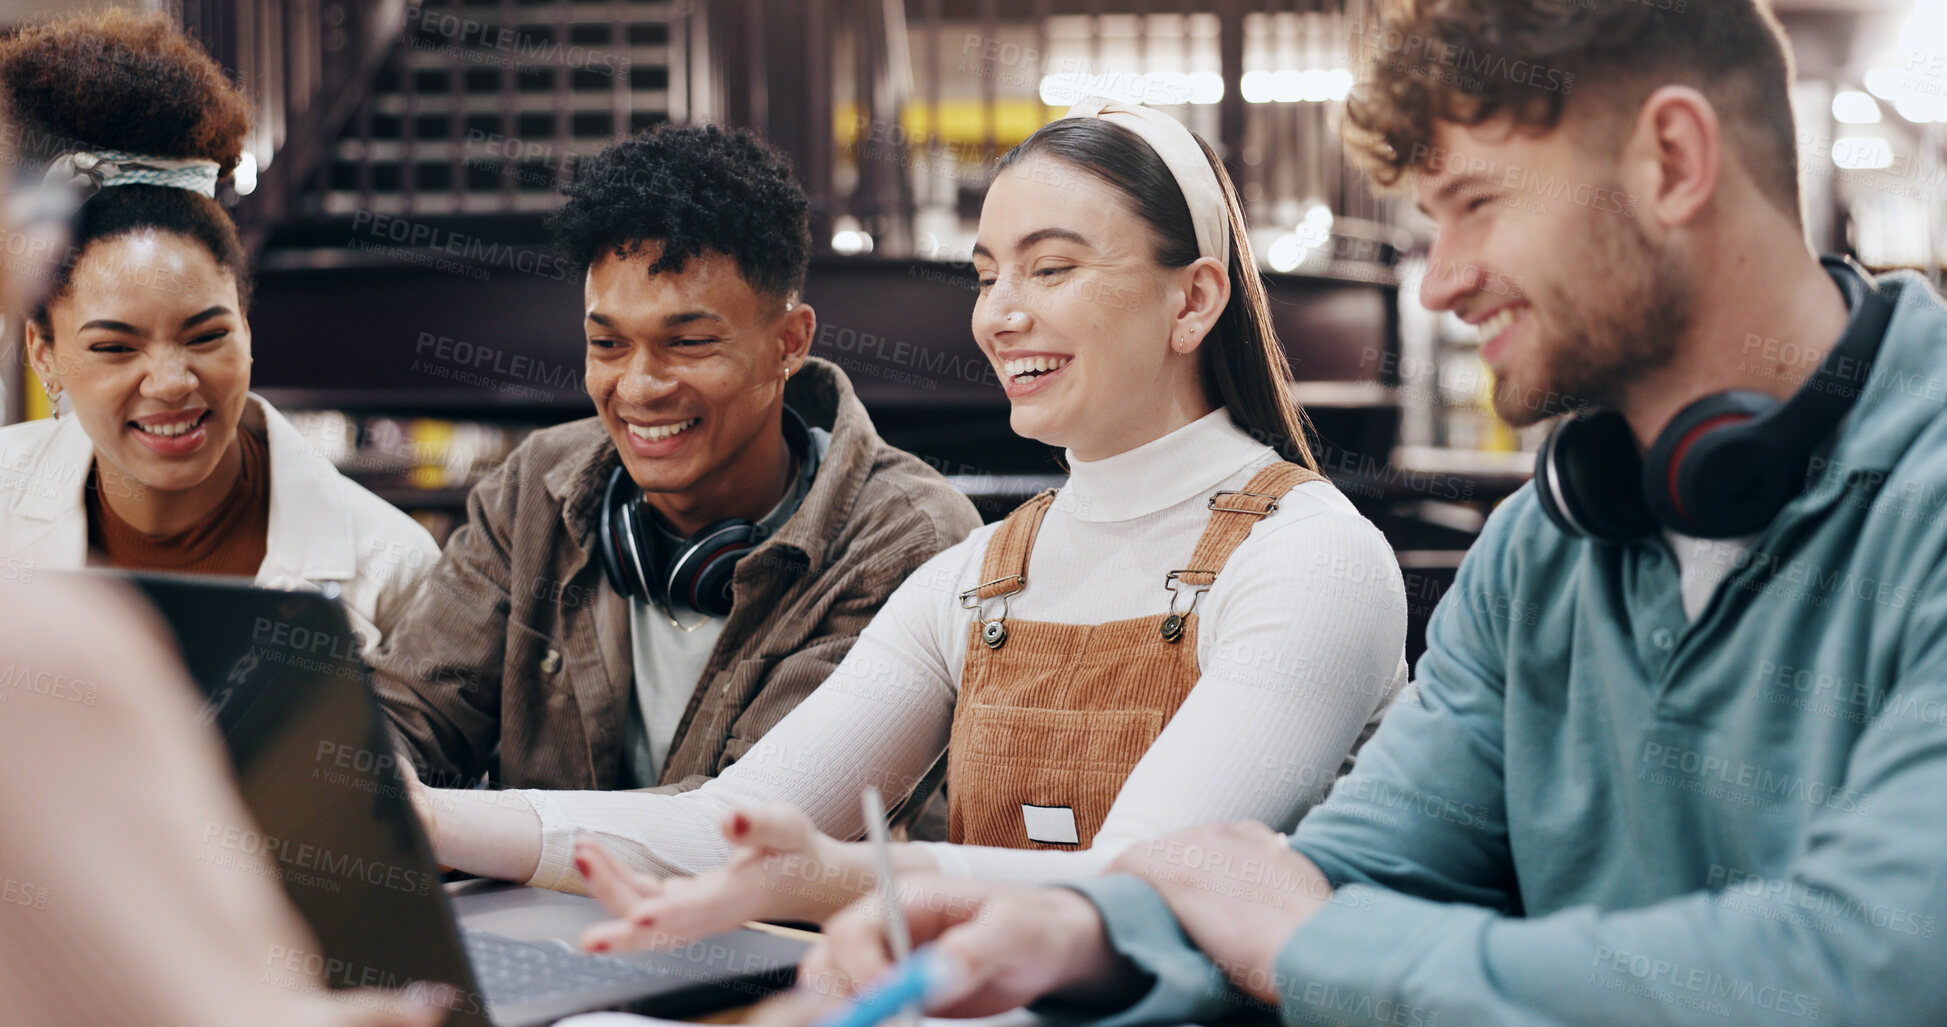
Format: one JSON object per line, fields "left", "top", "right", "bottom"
{"left": 1534, "top": 257, "right": 1892, "bottom": 542}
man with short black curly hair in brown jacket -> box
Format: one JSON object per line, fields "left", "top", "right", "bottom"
{"left": 372, "top": 125, "right": 979, "bottom": 844}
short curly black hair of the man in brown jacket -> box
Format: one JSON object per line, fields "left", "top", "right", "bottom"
{"left": 547, "top": 125, "right": 812, "bottom": 300}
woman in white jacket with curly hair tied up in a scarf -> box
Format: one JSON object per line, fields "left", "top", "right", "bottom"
{"left": 0, "top": 10, "right": 438, "bottom": 645}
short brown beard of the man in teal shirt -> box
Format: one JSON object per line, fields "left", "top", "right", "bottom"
{"left": 1493, "top": 212, "right": 1696, "bottom": 429}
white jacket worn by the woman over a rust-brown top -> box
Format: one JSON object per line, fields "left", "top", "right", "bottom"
{"left": 0, "top": 394, "right": 440, "bottom": 651}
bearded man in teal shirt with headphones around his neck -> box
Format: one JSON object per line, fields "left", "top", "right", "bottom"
{"left": 763, "top": 0, "right": 1947, "bottom": 1027}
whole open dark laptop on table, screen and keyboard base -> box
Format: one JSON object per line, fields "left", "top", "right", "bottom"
{"left": 130, "top": 575, "right": 806, "bottom": 1027}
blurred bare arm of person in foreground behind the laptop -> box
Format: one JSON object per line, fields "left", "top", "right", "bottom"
{"left": 0, "top": 573, "right": 444, "bottom": 1027}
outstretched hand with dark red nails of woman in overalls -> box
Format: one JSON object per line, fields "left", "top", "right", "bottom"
{"left": 574, "top": 805, "right": 878, "bottom": 953}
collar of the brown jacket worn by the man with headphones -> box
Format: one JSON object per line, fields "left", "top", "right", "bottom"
{"left": 541, "top": 357, "right": 878, "bottom": 573}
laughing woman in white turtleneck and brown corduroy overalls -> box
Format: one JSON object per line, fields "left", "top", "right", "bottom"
{"left": 422, "top": 101, "right": 1406, "bottom": 947}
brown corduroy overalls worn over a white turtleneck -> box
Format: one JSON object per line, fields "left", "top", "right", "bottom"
{"left": 946, "top": 464, "right": 1320, "bottom": 850}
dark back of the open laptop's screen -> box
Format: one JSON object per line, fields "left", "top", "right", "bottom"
{"left": 134, "top": 575, "right": 489, "bottom": 1027}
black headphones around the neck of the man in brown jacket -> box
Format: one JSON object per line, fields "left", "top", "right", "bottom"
{"left": 596, "top": 407, "right": 818, "bottom": 618}
